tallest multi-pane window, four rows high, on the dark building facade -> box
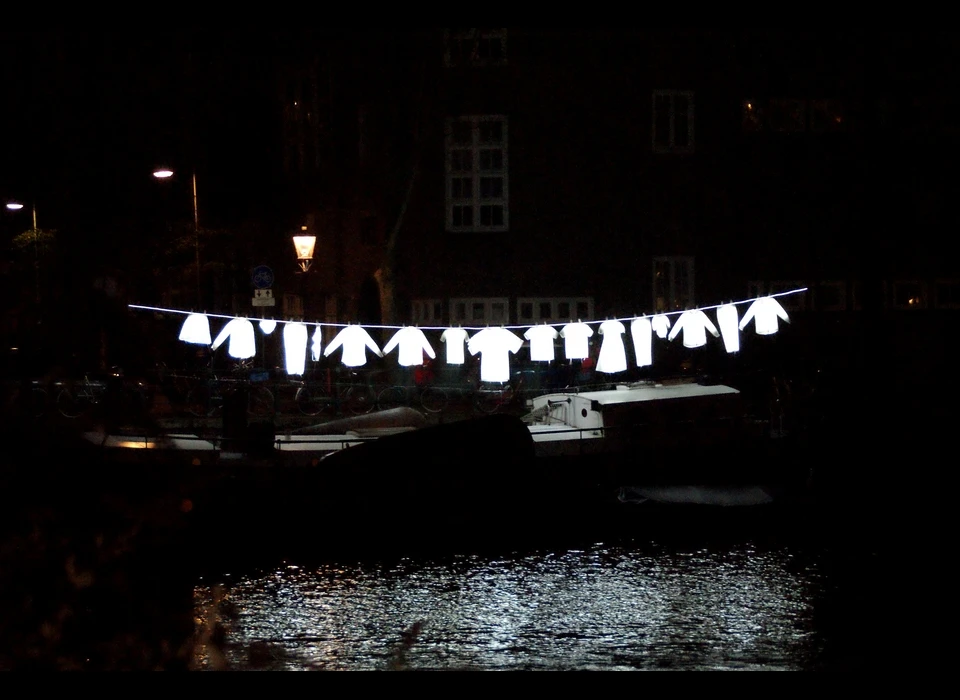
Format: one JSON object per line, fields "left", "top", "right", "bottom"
{"left": 446, "top": 116, "right": 509, "bottom": 231}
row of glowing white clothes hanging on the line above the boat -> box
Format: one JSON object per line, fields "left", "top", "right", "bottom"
{"left": 180, "top": 297, "right": 790, "bottom": 382}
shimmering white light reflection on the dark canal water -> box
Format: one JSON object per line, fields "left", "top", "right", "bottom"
{"left": 189, "top": 544, "right": 821, "bottom": 670}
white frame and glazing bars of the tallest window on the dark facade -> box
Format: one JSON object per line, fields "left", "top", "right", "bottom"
{"left": 444, "top": 115, "right": 510, "bottom": 233}
